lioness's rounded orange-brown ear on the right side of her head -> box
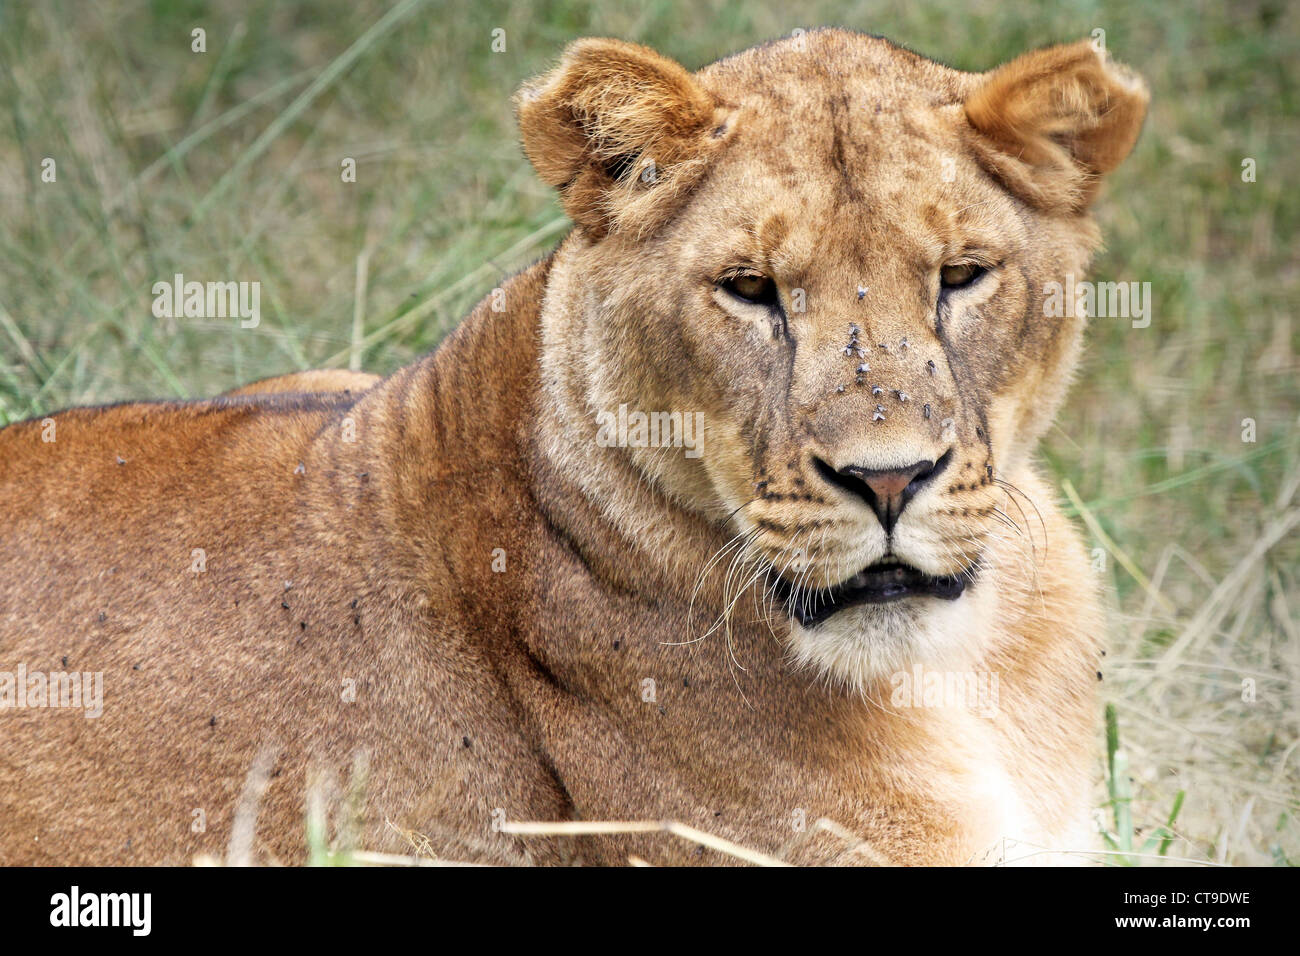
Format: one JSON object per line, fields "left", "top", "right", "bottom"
{"left": 966, "top": 40, "right": 1149, "bottom": 212}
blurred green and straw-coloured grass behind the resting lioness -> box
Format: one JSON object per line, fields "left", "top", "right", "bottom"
{"left": 0, "top": 0, "right": 1300, "bottom": 865}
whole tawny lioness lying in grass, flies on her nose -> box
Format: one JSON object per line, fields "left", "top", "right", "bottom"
{"left": 0, "top": 30, "right": 1147, "bottom": 864}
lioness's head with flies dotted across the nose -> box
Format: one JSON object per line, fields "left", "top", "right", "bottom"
{"left": 517, "top": 30, "right": 1147, "bottom": 683}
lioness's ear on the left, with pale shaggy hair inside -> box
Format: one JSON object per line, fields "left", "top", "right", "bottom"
{"left": 515, "top": 39, "right": 731, "bottom": 238}
